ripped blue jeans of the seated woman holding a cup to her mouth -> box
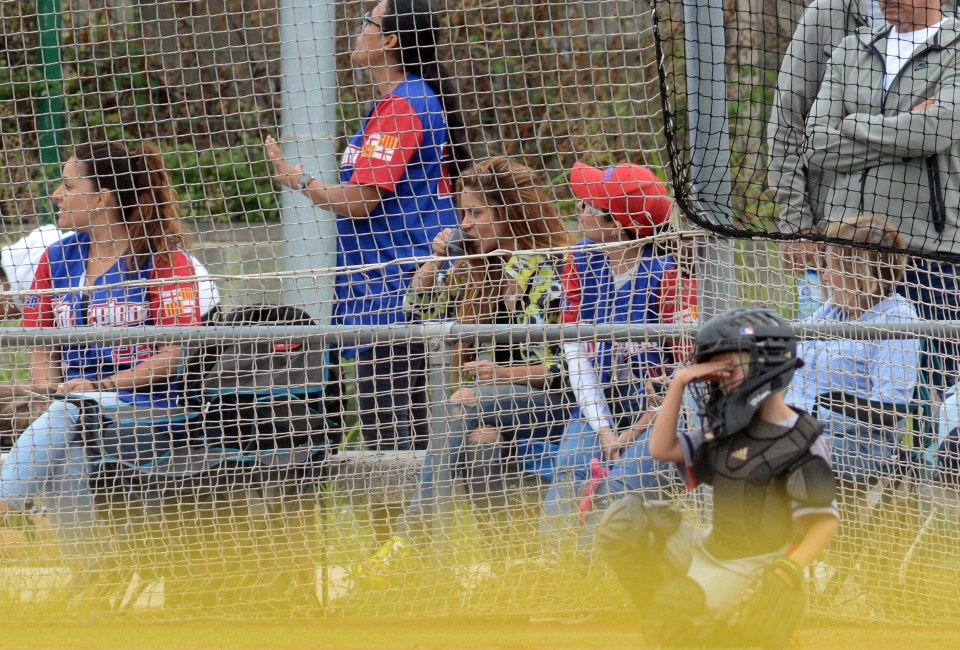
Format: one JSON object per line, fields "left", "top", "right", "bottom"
{"left": 398, "top": 384, "right": 568, "bottom": 534}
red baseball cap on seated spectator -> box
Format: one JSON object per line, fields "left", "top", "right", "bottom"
{"left": 570, "top": 162, "right": 670, "bottom": 237}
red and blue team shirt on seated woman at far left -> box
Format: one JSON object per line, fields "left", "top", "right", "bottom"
{"left": 22, "top": 233, "right": 200, "bottom": 407}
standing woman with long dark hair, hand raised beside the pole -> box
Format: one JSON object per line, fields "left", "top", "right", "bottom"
{"left": 266, "top": 0, "right": 470, "bottom": 448}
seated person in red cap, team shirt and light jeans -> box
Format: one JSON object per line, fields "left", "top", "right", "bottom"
{"left": 541, "top": 163, "right": 695, "bottom": 551}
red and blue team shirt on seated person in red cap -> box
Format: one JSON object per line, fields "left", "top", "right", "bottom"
{"left": 561, "top": 239, "right": 696, "bottom": 390}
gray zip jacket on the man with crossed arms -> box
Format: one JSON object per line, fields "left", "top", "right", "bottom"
{"left": 807, "top": 17, "right": 960, "bottom": 255}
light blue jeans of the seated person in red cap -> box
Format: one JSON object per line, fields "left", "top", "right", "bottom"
{"left": 540, "top": 420, "right": 675, "bottom": 555}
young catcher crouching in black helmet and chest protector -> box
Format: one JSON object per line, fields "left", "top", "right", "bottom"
{"left": 598, "top": 309, "right": 838, "bottom": 648}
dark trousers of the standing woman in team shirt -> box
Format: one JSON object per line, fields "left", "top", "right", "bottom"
{"left": 356, "top": 343, "right": 429, "bottom": 449}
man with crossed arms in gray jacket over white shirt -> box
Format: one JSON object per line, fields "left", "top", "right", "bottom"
{"left": 806, "top": 0, "right": 960, "bottom": 386}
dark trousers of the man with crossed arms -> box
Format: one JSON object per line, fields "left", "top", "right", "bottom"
{"left": 904, "top": 257, "right": 960, "bottom": 393}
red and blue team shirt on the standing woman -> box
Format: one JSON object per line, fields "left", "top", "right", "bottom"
{"left": 334, "top": 75, "right": 457, "bottom": 354}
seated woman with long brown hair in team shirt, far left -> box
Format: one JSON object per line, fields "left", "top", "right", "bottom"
{"left": 0, "top": 142, "right": 200, "bottom": 512}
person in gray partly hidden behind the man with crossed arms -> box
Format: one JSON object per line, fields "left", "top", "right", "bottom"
{"left": 767, "top": 0, "right": 885, "bottom": 240}
